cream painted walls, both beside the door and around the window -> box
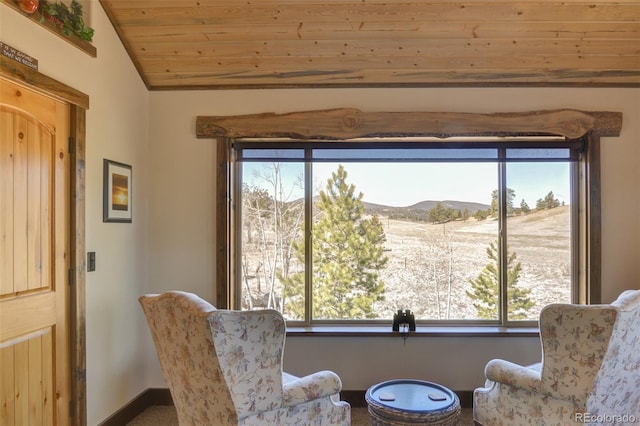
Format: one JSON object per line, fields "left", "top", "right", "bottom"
{"left": 0, "top": 0, "right": 640, "bottom": 425}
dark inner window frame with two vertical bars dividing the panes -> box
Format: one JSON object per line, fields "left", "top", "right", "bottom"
{"left": 235, "top": 137, "right": 585, "bottom": 328}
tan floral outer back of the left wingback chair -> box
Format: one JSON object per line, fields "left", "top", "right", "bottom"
{"left": 139, "top": 291, "right": 238, "bottom": 426}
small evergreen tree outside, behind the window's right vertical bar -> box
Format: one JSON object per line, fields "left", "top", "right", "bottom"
{"left": 466, "top": 241, "right": 534, "bottom": 320}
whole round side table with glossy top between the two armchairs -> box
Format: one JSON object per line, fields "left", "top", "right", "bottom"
{"left": 365, "top": 380, "right": 460, "bottom": 426}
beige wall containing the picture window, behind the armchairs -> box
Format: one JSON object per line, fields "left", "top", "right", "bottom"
{"left": 146, "top": 88, "right": 640, "bottom": 390}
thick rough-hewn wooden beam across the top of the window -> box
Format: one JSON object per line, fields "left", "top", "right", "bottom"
{"left": 196, "top": 108, "right": 622, "bottom": 140}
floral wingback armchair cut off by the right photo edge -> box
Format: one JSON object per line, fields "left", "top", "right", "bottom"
{"left": 473, "top": 290, "right": 640, "bottom": 426}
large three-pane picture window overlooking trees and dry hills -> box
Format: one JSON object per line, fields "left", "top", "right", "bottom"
{"left": 231, "top": 138, "right": 583, "bottom": 325}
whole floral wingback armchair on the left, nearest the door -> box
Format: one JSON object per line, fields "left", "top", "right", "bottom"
{"left": 139, "top": 291, "right": 351, "bottom": 426}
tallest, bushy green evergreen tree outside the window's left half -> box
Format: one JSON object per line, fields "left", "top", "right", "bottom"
{"left": 283, "top": 165, "right": 388, "bottom": 319}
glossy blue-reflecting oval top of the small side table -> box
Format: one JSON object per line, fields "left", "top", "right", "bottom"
{"left": 365, "top": 379, "right": 459, "bottom": 414}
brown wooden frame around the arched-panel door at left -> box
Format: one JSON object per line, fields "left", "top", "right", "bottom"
{"left": 0, "top": 57, "right": 89, "bottom": 426}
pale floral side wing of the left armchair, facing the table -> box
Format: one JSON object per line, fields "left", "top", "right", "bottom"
{"left": 209, "top": 309, "right": 285, "bottom": 419}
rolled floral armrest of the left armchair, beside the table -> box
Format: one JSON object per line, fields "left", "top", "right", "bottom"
{"left": 282, "top": 371, "right": 342, "bottom": 407}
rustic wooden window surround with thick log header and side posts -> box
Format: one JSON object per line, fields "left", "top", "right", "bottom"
{"left": 196, "top": 109, "right": 622, "bottom": 335}
